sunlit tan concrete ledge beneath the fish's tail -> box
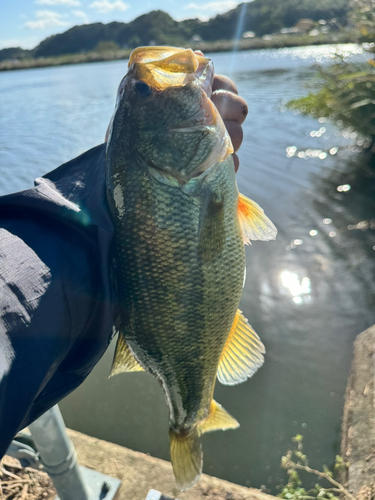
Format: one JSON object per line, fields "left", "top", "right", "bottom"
{"left": 68, "top": 429, "right": 275, "bottom": 500}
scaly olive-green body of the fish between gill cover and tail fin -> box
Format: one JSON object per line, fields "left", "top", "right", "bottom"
{"left": 116, "top": 160, "right": 245, "bottom": 429}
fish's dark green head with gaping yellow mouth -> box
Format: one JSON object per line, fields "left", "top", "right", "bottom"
{"left": 108, "top": 47, "right": 233, "bottom": 184}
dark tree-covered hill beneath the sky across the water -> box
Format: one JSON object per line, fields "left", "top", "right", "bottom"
{"left": 0, "top": 0, "right": 349, "bottom": 62}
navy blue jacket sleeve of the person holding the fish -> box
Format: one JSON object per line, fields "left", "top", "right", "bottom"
{"left": 0, "top": 144, "right": 116, "bottom": 457}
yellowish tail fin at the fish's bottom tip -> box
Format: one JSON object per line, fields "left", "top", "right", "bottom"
{"left": 169, "top": 427, "right": 203, "bottom": 491}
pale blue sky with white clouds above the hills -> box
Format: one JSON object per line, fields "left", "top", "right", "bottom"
{"left": 0, "top": 0, "right": 240, "bottom": 49}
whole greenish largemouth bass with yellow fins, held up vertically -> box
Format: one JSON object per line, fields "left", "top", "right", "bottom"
{"left": 106, "top": 47, "right": 277, "bottom": 490}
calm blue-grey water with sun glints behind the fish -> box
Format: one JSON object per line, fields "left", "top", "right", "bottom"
{"left": 0, "top": 46, "right": 375, "bottom": 491}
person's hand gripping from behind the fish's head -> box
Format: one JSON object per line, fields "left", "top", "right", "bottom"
{"left": 104, "top": 75, "right": 248, "bottom": 172}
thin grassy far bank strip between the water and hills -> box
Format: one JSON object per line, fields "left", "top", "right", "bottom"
{"left": 0, "top": 32, "right": 360, "bottom": 71}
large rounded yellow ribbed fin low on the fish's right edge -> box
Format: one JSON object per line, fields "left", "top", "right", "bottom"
{"left": 217, "top": 309, "right": 266, "bottom": 385}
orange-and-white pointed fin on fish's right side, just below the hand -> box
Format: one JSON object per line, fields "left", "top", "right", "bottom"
{"left": 238, "top": 194, "right": 277, "bottom": 245}
